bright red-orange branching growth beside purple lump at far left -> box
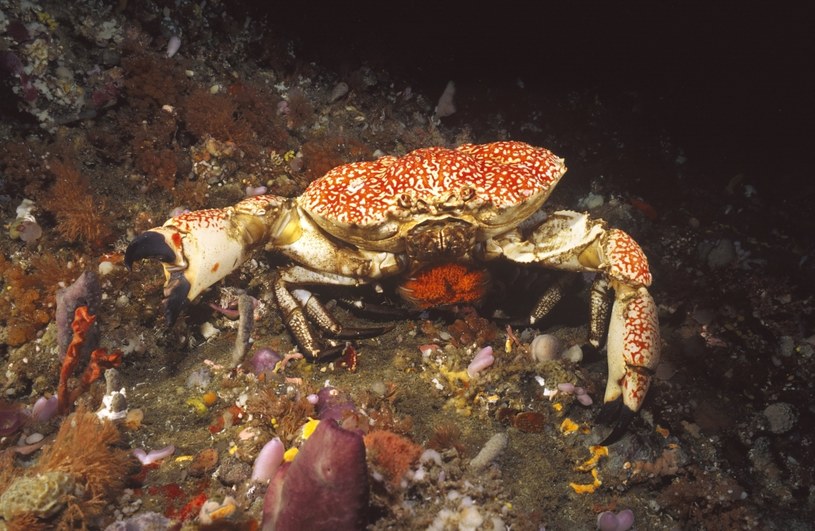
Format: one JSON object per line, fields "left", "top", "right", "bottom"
{"left": 57, "top": 306, "right": 122, "bottom": 414}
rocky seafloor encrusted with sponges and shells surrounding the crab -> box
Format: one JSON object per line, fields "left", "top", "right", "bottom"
{"left": 0, "top": 0, "right": 815, "bottom": 530}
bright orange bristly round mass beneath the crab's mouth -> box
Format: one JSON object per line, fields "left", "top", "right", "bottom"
{"left": 399, "top": 263, "right": 489, "bottom": 308}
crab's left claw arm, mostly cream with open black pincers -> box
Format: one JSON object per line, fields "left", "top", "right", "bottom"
{"left": 125, "top": 195, "right": 298, "bottom": 323}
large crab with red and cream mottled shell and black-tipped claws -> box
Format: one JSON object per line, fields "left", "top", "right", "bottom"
{"left": 125, "top": 141, "right": 660, "bottom": 443}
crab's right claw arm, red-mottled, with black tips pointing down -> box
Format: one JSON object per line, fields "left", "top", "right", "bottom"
{"left": 486, "top": 211, "right": 661, "bottom": 444}
